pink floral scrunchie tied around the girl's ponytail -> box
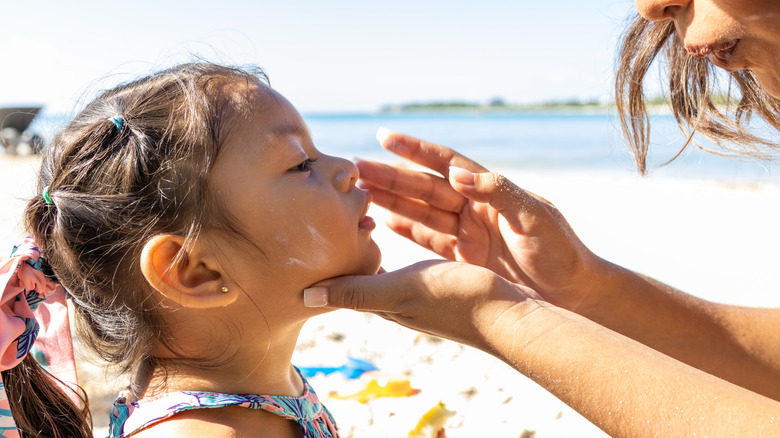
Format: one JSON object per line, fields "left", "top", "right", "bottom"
{"left": 0, "top": 237, "right": 78, "bottom": 437}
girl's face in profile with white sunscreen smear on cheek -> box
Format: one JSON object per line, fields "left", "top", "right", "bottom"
{"left": 206, "top": 87, "right": 381, "bottom": 307}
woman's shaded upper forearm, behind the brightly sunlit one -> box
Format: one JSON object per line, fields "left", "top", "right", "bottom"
{"left": 572, "top": 265, "right": 780, "bottom": 400}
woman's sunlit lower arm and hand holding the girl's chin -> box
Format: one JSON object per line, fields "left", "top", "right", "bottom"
{"left": 304, "top": 261, "right": 780, "bottom": 436}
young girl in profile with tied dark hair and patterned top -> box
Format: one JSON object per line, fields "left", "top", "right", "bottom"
{"left": 19, "top": 63, "right": 380, "bottom": 437}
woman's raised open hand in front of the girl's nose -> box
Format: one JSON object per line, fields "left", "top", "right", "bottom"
{"left": 357, "top": 129, "right": 611, "bottom": 309}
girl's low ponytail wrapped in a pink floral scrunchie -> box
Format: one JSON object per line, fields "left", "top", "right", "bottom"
{"left": 0, "top": 238, "right": 91, "bottom": 438}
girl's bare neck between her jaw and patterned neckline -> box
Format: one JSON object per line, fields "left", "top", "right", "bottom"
{"left": 136, "top": 323, "right": 304, "bottom": 398}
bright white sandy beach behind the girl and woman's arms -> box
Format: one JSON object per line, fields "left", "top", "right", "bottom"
{"left": 0, "top": 156, "right": 780, "bottom": 438}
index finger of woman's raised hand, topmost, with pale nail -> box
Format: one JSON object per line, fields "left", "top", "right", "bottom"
{"left": 376, "top": 128, "right": 487, "bottom": 176}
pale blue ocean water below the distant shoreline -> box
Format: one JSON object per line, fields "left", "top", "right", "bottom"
{"left": 27, "top": 112, "right": 780, "bottom": 182}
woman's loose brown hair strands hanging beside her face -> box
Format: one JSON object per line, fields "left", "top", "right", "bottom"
{"left": 615, "top": 15, "right": 780, "bottom": 173}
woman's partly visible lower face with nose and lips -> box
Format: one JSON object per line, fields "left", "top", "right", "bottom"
{"left": 634, "top": 0, "right": 780, "bottom": 98}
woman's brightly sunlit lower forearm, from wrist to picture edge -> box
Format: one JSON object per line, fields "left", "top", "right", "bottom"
{"left": 485, "top": 302, "right": 780, "bottom": 437}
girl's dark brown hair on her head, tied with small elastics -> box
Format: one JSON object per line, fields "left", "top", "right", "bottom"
{"left": 17, "top": 62, "right": 267, "bottom": 434}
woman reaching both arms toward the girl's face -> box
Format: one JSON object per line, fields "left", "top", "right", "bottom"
{"left": 304, "top": 0, "right": 780, "bottom": 436}
